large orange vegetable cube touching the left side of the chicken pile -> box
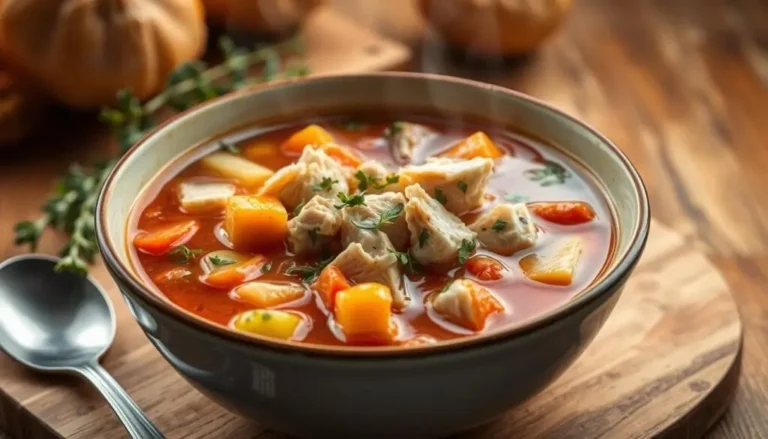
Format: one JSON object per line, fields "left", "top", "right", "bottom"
{"left": 224, "top": 195, "right": 288, "bottom": 250}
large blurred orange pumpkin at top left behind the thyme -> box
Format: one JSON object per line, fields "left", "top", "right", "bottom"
{"left": 0, "top": 0, "right": 207, "bottom": 108}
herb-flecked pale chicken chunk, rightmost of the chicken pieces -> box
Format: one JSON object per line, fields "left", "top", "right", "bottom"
{"left": 469, "top": 203, "right": 538, "bottom": 256}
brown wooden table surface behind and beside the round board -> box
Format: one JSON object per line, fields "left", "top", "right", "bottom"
{"left": 0, "top": 0, "right": 768, "bottom": 439}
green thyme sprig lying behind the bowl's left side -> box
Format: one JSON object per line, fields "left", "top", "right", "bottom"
{"left": 14, "top": 37, "right": 309, "bottom": 274}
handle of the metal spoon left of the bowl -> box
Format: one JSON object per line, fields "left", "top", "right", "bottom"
{"left": 76, "top": 363, "right": 165, "bottom": 439}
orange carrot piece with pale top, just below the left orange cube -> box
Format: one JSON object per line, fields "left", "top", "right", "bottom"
{"left": 200, "top": 250, "right": 267, "bottom": 290}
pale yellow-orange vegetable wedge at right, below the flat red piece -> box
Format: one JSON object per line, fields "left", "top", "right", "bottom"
{"left": 520, "top": 238, "right": 584, "bottom": 286}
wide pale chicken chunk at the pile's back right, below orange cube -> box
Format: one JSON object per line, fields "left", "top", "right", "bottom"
{"left": 400, "top": 158, "right": 493, "bottom": 215}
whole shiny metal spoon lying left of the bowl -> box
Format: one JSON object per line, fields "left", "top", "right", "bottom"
{"left": 0, "top": 255, "right": 164, "bottom": 439}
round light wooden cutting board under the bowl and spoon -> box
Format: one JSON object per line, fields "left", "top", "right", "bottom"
{"left": 0, "top": 219, "right": 742, "bottom": 439}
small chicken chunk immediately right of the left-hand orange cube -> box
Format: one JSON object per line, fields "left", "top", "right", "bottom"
{"left": 288, "top": 195, "right": 341, "bottom": 254}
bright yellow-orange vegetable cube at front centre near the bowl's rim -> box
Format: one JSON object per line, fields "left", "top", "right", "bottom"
{"left": 334, "top": 283, "right": 395, "bottom": 343}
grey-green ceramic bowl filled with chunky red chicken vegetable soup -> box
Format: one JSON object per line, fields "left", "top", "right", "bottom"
{"left": 97, "top": 73, "right": 649, "bottom": 437}
